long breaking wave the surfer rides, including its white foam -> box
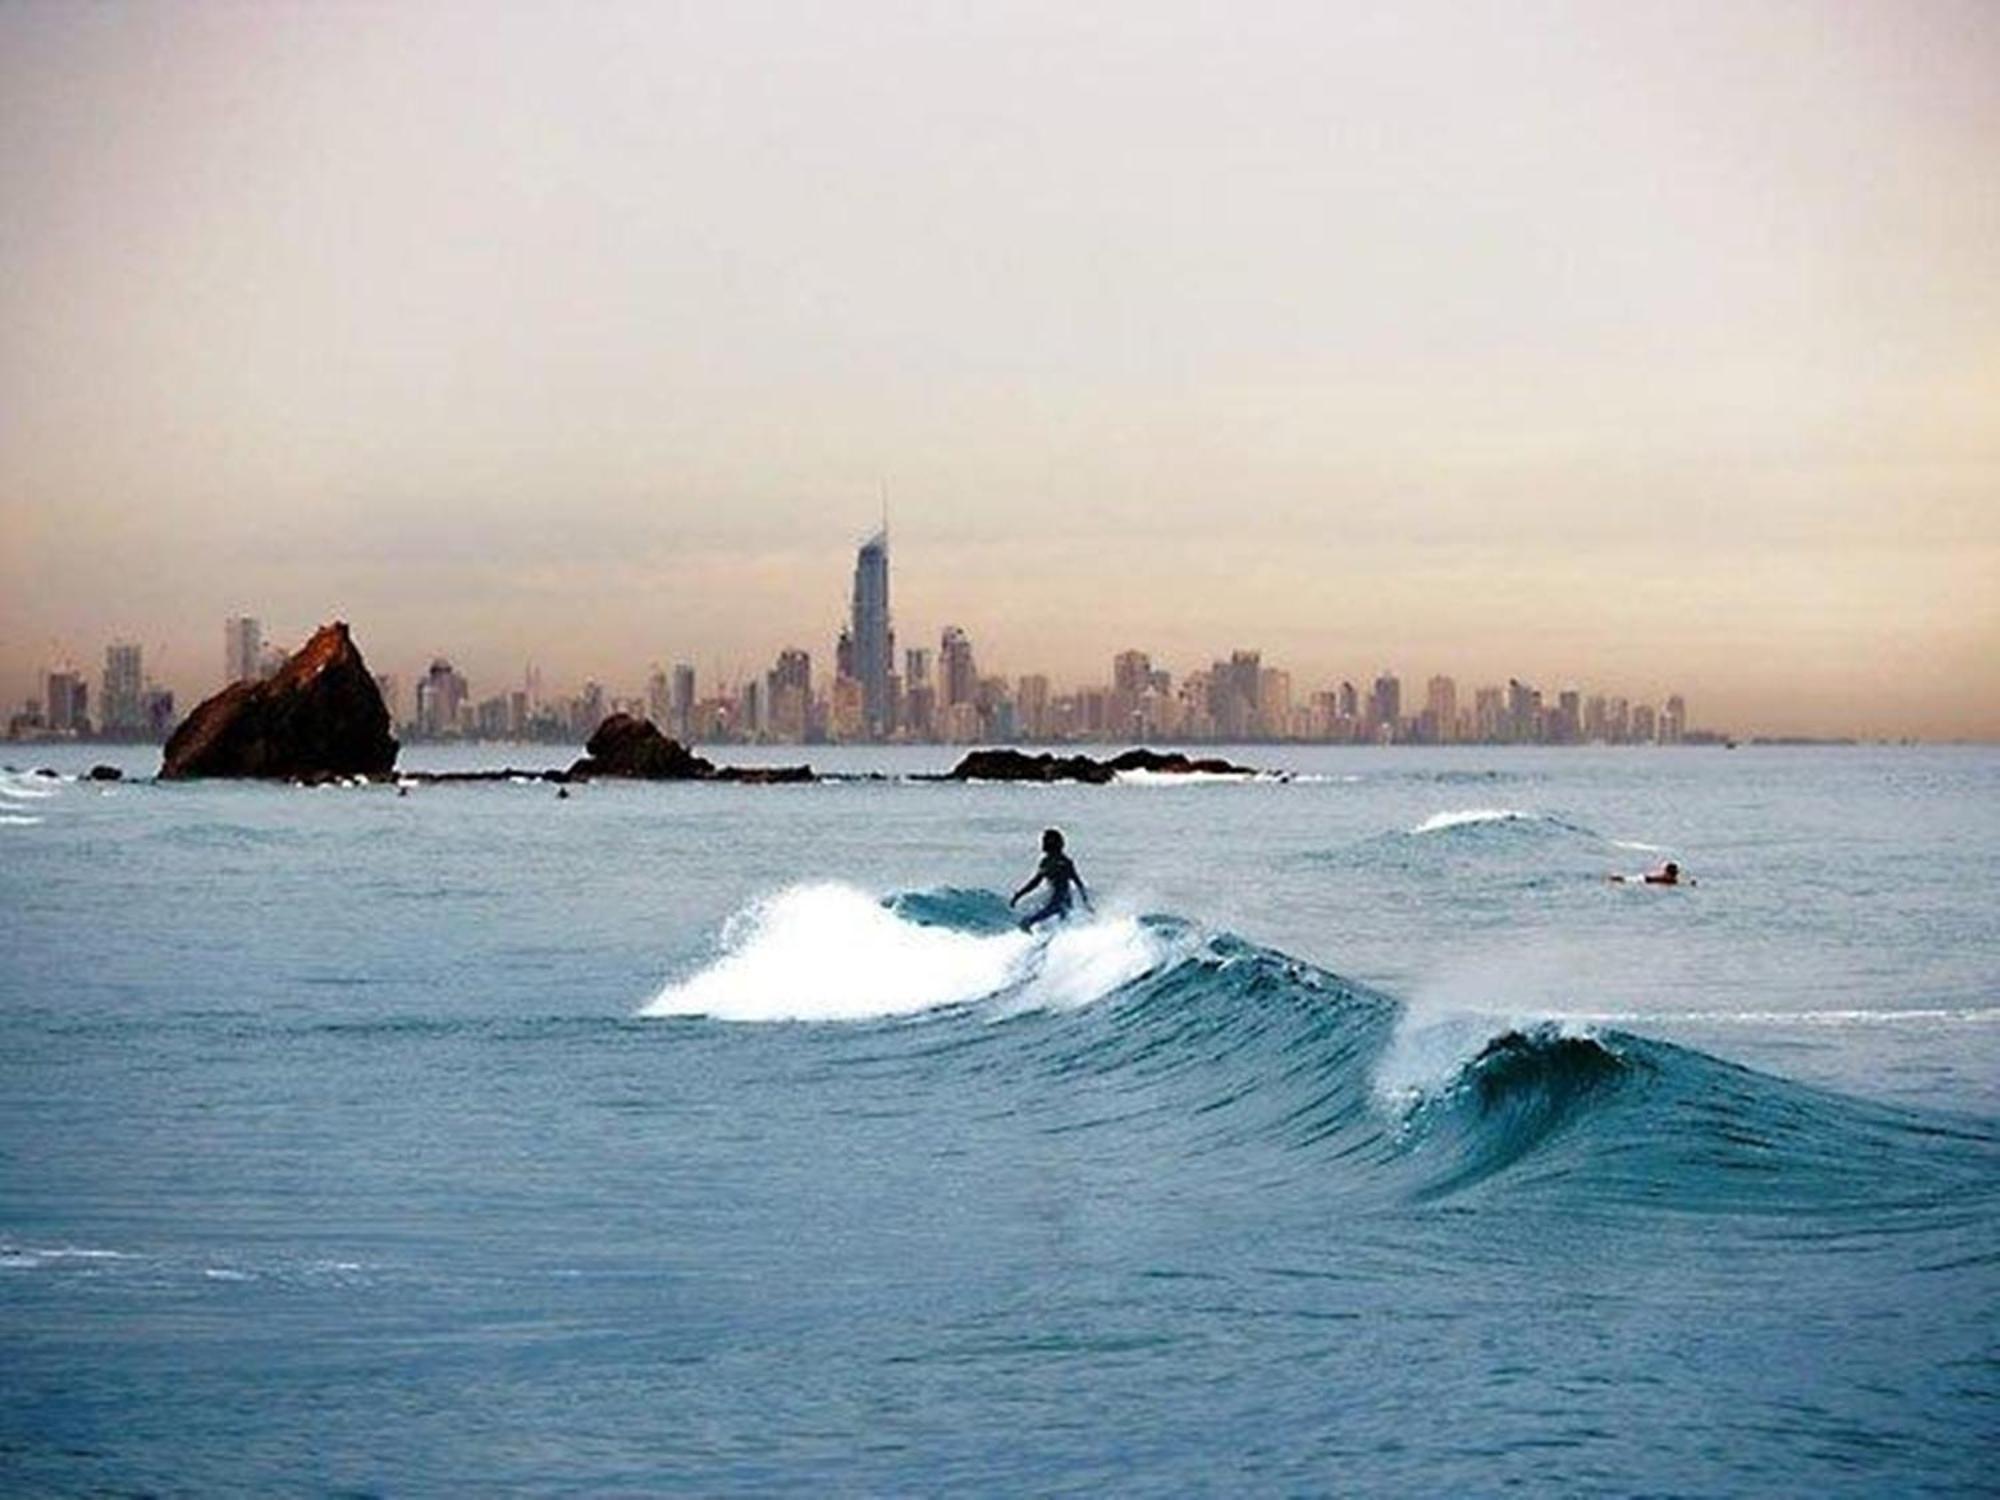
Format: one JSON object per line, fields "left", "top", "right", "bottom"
{"left": 642, "top": 884, "right": 2000, "bottom": 1226}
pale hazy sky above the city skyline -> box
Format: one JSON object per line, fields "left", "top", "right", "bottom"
{"left": 0, "top": 0, "right": 2000, "bottom": 736}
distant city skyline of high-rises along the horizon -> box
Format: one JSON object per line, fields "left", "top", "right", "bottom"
{"left": 10, "top": 548, "right": 1720, "bottom": 744}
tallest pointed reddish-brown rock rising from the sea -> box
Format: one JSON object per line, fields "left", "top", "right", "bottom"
{"left": 160, "top": 620, "right": 396, "bottom": 780}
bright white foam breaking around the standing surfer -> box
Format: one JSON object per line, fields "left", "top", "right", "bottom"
{"left": 640, "top": 882, "right": 1166, "bottom": 1022}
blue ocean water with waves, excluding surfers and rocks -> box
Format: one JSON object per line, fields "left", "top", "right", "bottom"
{"left": 0, "top": 746, "right": 2000, "bottom": 1496}
